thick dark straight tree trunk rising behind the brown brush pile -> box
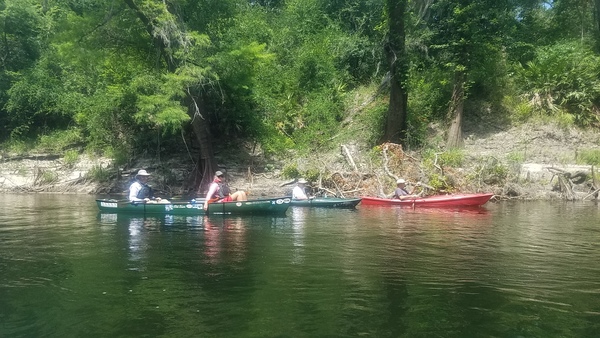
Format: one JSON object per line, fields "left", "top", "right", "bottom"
{"left": 381, "top": 0, "right": 408, "bottom": 145}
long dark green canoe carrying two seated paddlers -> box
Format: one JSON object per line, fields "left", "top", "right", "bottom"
{"left": 96, "top": 197, "right": 291, "bottom": 215}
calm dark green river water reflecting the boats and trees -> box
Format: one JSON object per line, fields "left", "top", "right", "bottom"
{"left": 0, "top": 195, "right": 600, "bottom": 337}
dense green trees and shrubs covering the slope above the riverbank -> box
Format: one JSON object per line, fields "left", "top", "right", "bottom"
{"left": 0, "top": 0, "right": 600, "bottom": 157}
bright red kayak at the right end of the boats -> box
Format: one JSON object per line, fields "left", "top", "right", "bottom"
{"left": 362, "top": 194, "right": 494, "bottom": 208}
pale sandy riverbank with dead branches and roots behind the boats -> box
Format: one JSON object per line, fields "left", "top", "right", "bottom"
{"left": 0, "top": 123, "right": 600, "bottom": 199}
